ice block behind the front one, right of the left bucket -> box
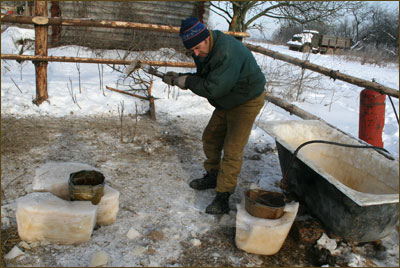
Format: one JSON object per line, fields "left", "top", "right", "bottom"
{"left": 96, "top": 185, "right": 119, "bottom": 225}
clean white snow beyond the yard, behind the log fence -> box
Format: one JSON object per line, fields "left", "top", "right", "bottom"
{"left": 1, "top": 27, "right": 399, "bottom": 156}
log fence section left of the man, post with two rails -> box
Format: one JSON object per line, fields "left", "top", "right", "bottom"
{"left": 1, "top": 1, "right": 249, "bottom": 119}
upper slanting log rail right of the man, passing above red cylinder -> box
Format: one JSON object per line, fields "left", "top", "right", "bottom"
{"left": 245, "top": 44, "right": 399, "bottom": 98}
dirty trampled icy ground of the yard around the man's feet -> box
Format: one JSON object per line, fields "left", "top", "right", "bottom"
{"left": 2, "top": 116, "right": 398, "bottom": 267}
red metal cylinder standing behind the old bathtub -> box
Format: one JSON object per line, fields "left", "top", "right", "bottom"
{"left": 358, "top": 89, "right": 386, "bottom": 148}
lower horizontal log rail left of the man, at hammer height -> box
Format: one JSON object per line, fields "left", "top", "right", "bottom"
{"left": 1, "top": 54, "right": 195, "bottom": 68}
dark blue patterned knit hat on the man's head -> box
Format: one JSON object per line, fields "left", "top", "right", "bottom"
{"left": 179, "top": 18, "right": 210, "bottom": 49}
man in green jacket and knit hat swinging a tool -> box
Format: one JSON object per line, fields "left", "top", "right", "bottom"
{"left": 163, "top": 18, "right": 265, "bottom": 214}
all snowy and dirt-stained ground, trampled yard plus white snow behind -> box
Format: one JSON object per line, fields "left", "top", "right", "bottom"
{"left": 1, "top": 27, "right": 399, "bottom": 267}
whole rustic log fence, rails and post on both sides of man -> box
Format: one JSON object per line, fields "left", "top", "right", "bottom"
{"left": 1, "top": 1, "right": 399, "bottom": 120}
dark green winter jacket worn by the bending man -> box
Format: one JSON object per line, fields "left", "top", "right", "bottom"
{"left": 186, "top": 30, "right": 266, "bottom": 109}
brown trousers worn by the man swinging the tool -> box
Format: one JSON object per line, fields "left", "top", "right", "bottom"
{"left": 202, "top": 93, "right": 265, "bottom": 193}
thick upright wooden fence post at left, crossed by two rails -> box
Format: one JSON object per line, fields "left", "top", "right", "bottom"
{"left": 33, "top": 1, "right": 49, "bottom": 106}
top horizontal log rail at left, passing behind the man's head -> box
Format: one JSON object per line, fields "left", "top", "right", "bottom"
{"left": 1, "top": 14, "right": 250, "bottom": 37}
